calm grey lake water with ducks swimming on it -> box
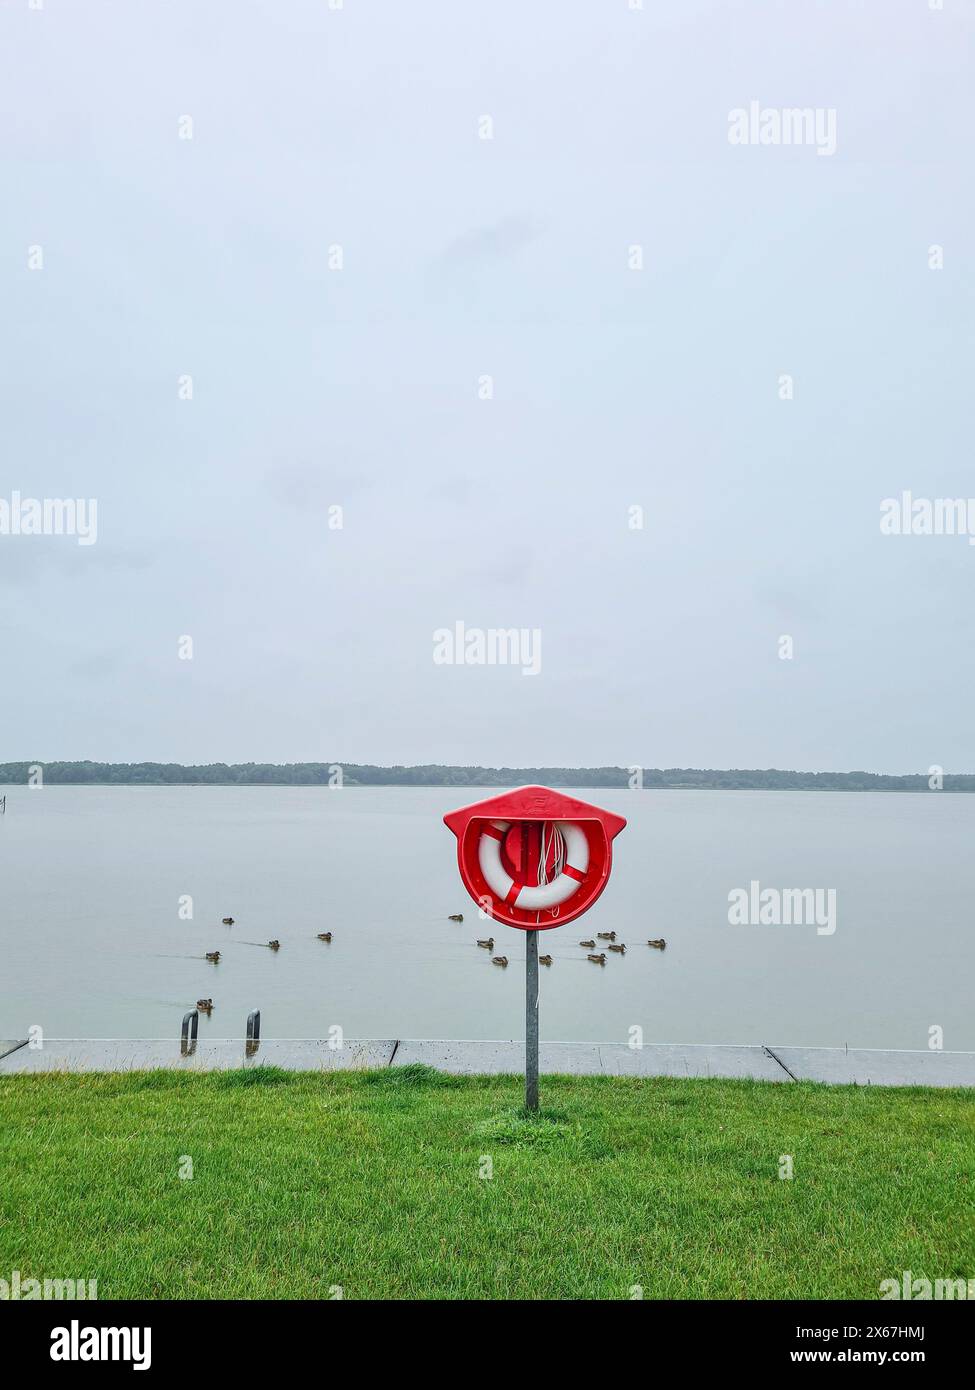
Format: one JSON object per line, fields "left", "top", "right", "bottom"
{"left": 0, "top": 787, "right": 975, "bottom": 1049}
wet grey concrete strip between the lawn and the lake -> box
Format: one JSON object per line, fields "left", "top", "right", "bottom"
{"left": 0, "top": 1038, "right": 975, "bottom": 1086}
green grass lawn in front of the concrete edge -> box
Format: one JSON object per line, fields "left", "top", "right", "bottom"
{"left": 0, "top": 1068, "right": 975, "bottom": 1298}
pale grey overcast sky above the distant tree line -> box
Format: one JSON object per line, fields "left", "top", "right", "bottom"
{"left": 0, "top": 0, "right": 975, "bottom": 771}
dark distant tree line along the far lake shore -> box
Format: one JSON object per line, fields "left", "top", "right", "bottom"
{"left": 0, "top": 759, "right": 975, "bottom": 791}
